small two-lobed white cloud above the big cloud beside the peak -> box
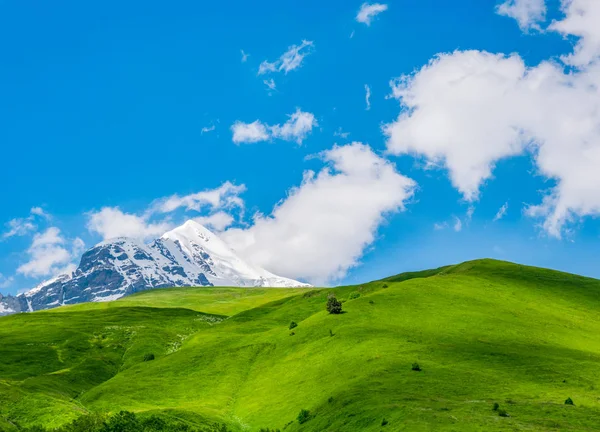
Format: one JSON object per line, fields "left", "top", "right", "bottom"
{"left": 231, "top": 108, "right": 318, "bottom": 144}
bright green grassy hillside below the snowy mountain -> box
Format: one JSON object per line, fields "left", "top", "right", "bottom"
{"left": 0, "top": 260, "right": 600, "bottom": 432}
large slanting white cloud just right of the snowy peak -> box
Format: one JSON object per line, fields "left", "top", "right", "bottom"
{"left": 224, "top": 143, "right": 415, "bottom": 284}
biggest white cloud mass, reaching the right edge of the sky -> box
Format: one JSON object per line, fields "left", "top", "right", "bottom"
{"left": 384, "top": 0, "right": 600, "bottom": 237}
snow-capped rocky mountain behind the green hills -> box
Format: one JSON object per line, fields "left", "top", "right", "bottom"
{"left": 0, "top": 221, "right": 310, "bottom": 315}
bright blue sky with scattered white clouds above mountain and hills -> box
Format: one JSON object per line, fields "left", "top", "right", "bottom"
{"left": 0, "top": 0, "right": 600, "bottom": 293}
